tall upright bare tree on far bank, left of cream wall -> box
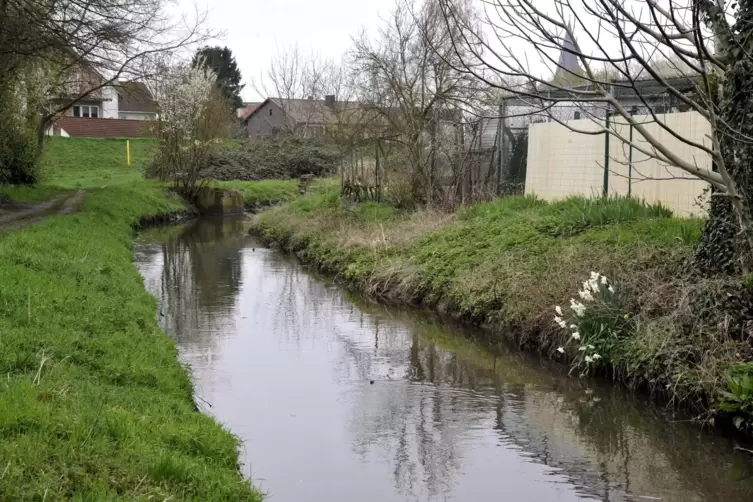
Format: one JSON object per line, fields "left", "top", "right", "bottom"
{"left": 351, "top": 0, "right": 479, "bottom": 203}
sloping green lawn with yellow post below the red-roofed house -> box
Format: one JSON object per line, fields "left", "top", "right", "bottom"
{"left": 42, "top": 137, "right": 157, "bottom": 188}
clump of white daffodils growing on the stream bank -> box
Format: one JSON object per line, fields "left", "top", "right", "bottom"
{"left": 554, "top": 272, "right": 632, "bottom": 374}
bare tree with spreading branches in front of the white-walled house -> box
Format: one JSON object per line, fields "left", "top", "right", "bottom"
{"left": 0, "top": 0, "right": 212, "bottom": 145}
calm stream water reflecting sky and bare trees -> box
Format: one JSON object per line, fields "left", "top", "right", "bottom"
{"left": 136, "top": 220, "right": 753, "bottom": 502}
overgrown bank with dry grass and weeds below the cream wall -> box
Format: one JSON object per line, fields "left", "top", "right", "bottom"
{"left": 255, "top": 186, "right": 753, "bottom": 422}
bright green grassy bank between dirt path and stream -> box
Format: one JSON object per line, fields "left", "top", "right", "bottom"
{"left": 0, "top": 184, "right": 260, "bottom": 501}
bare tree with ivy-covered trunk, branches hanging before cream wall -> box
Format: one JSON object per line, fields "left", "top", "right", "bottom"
{"left": 439, "top": 0, "right": 753, "bottom": 268}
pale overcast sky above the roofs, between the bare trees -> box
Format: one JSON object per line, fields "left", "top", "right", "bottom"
{"left": 188, "top": 0, "right": 395, "bottom": 101}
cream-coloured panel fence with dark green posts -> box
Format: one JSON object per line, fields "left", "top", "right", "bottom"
{"left": 525, "top": 112, "right": 711, "bottom": 216}
